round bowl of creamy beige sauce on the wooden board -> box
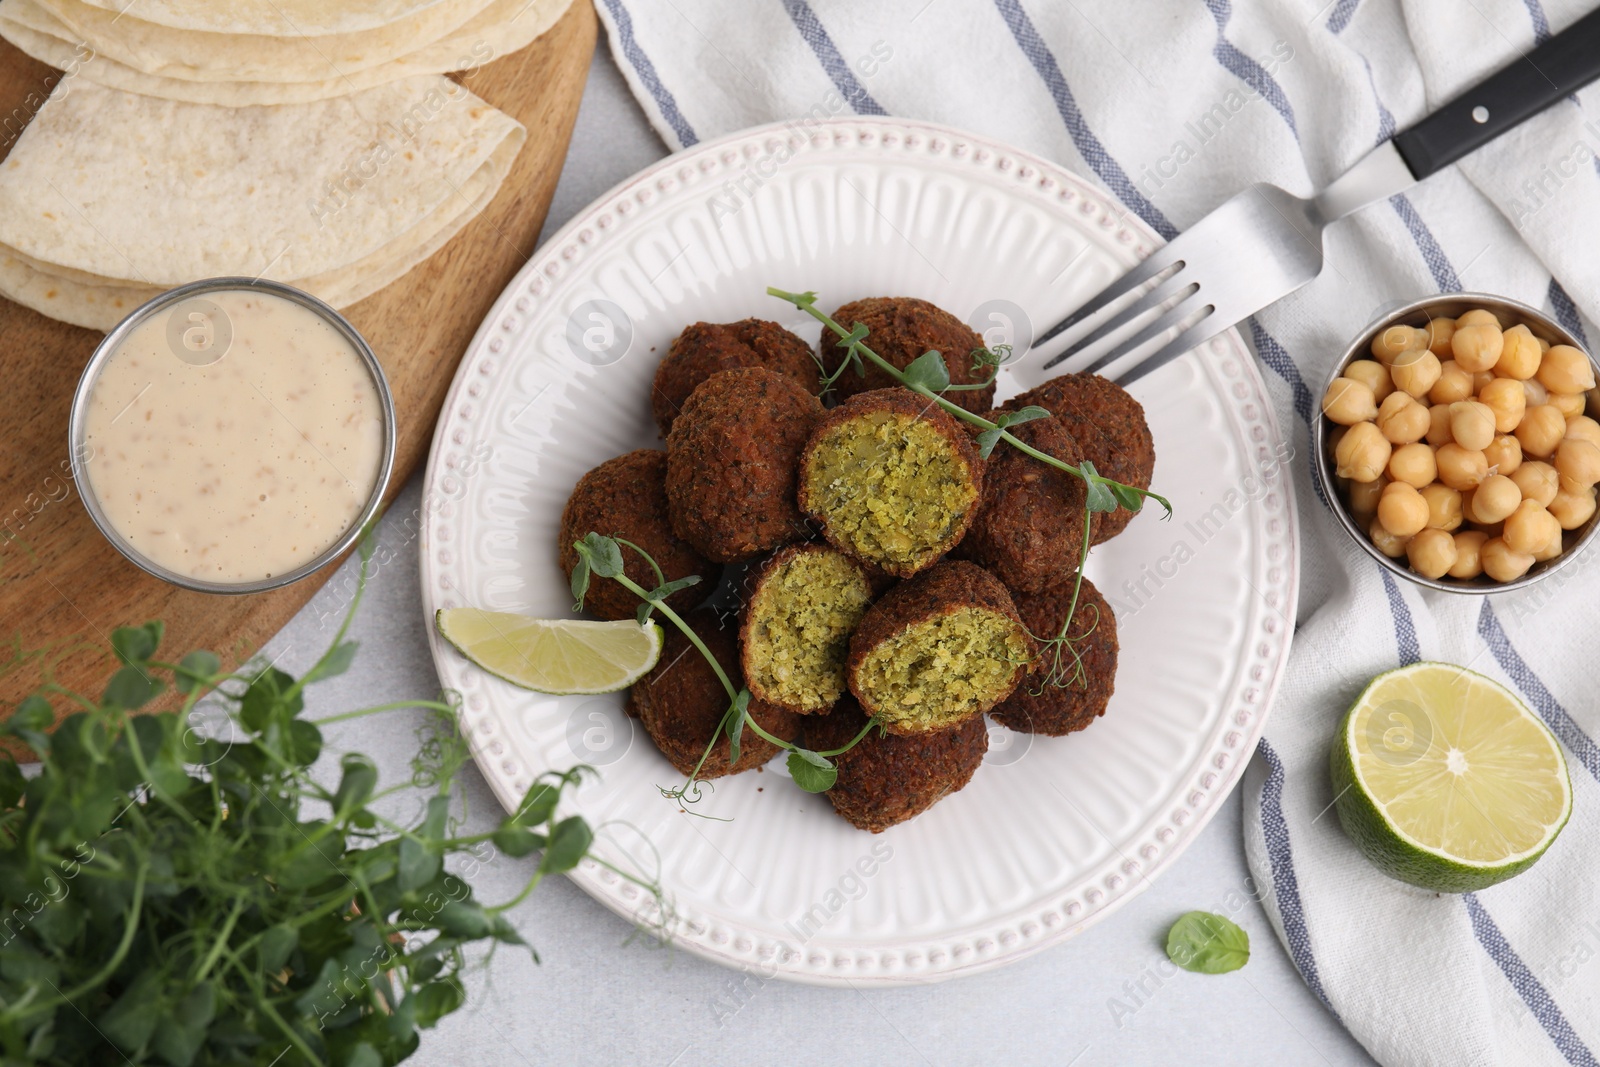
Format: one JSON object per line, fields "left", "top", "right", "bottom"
{"left": 69, "top": 278, "right": 395, "bottom": 593}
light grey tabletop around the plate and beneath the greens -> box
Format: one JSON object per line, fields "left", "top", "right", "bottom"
{"left": 264, "top": 40, "right": 1373, "bottom": 1067}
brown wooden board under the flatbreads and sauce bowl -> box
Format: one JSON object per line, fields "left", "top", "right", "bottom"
{"left": 0, "top": 0, "right": 595, "bottom": 715}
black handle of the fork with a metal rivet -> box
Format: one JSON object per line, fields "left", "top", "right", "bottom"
{"left": 1394, "top": 10, "right": 1600, "bottom": 181}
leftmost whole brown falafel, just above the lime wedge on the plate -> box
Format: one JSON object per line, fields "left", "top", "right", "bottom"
{"left": 557, "top": 448, "right": 722, "bottom": 619}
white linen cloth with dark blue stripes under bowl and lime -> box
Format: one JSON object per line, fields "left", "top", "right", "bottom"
{"left": 597, "top": 0, "right": 1600, "bottom": 1067}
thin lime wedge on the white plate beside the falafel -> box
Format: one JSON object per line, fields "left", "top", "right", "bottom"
{"left": 435, "top": 608, "right": 661, "bottom": 696}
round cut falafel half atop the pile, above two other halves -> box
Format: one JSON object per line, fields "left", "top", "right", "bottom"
{"left": 800, "top": 387, "right": 982, "bottom": 577}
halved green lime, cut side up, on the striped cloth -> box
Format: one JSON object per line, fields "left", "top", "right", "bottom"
{"left": 1331, "top": 662, "right": 1573, "bottom": 893}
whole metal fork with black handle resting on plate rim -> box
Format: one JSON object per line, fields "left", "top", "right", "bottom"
{"left": 1034, "top": 10, "right": 1600, "bottom": 384}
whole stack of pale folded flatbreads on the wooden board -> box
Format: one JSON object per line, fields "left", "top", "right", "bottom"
{"left": 0, "top": 0, "right": 571, "bottom": 330}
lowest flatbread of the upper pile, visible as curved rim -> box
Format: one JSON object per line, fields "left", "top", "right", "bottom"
{"left": 0, "top": 0, "right": 573, "bottom": 107}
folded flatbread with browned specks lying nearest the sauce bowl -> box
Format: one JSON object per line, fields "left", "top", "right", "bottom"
{"left": 0, "top": 75, "right": 526, "bottom": 330}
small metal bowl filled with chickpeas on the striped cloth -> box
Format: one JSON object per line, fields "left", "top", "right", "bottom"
{"left": 1315, "top": 293, "right": 1600, "bottom": 593}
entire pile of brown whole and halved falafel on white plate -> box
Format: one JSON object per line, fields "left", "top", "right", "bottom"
{"left": 558, "top": 298, "right": 1155, "bottom": 833}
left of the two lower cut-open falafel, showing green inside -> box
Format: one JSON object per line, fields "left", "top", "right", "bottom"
{"left": 739, "top": 544, "right": 872, "bottom": 715}
